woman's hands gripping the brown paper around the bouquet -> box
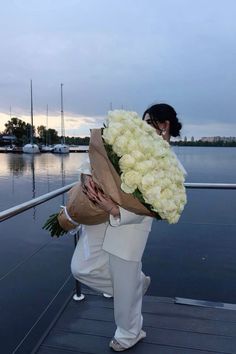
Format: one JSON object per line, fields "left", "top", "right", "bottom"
{"left": 82, "top": 175, "right": 120, "bottom": 217}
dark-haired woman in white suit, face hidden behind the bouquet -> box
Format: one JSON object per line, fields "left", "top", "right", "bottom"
{"left": 71, "top": 104, "right": 182, "bottom": 351}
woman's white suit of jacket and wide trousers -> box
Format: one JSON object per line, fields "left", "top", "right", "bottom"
{"left": 71, "top": 156, "right": 153, "bottom": 348}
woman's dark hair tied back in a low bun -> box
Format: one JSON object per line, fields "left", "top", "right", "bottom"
{"left": 142, "top": 103, "right": 182, "bottom": 137}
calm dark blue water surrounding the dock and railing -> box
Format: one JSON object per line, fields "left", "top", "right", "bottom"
{"left": 0, "top": 147, "right": 236, "bottom": 354}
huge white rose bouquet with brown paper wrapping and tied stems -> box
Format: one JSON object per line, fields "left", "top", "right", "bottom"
{"left": 44, "top": 110, "right": 186, "bottom": 236}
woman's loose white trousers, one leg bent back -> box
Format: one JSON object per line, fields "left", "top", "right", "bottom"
{"left": 71, "top": 223, "right": 145, "bottom": 348}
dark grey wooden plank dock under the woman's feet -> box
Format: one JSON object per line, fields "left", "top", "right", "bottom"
{"left": 33, "top": 293, "right": 236, "bottom": 354}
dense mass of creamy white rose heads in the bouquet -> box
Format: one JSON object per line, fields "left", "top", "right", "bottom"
{"left": 102, "top": 110, "right": 186, "bottom": 223}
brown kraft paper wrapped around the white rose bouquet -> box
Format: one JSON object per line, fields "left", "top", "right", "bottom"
{"left": 58, "top": 129, "right": 153, "bottom": 231}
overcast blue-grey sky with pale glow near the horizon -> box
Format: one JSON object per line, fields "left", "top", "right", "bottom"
{"left": 0, "top": 0, "right": 236, "bottom": 138}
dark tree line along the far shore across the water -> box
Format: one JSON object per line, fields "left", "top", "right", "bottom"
{"left": 0, "top": 117, "right": 236, "bottom": 147}
